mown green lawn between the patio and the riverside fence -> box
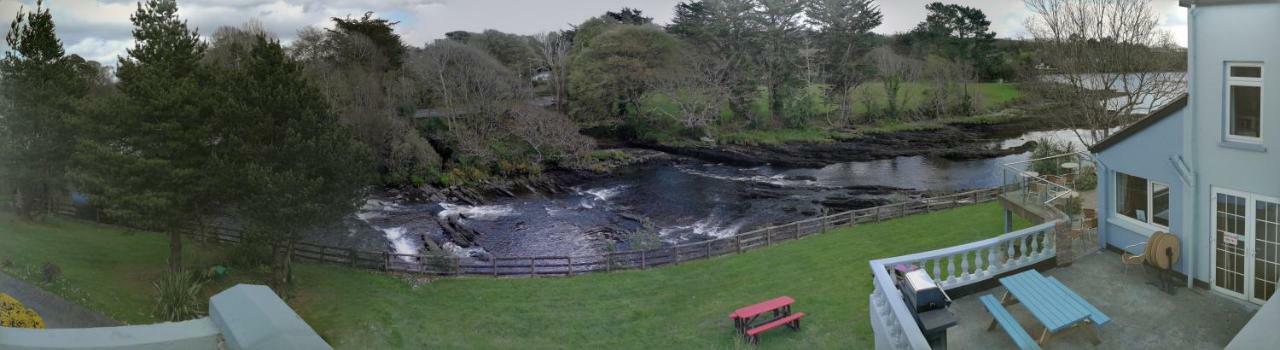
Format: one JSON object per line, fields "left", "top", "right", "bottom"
{"left": 0, "top": 204, "right": 1024, "bottom": 349}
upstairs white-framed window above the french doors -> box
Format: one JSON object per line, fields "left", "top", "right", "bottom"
{"left": 1226, "top": 63, "right": 1262, "bottom": 142}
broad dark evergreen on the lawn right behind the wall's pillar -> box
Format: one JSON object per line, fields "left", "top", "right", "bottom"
{"left": 214, "top": 33, "right": 375, "bottom": 295}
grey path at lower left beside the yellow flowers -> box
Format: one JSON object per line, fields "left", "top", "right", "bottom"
{"left": 0, "top": 269, "right": 123, "bottom": 328}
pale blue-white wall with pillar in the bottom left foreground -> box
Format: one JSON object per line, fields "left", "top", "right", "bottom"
{"left": 0, "top": 285, "right": 332, "bottom": 350}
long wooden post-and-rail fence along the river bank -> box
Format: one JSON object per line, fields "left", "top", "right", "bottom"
{"left": 37, "top": 188, "right": 1000, "bottom": 277}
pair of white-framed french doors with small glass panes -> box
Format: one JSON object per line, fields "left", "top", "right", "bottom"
{"left": 1212, "top": 188, "right": 1280, "bottom": 303}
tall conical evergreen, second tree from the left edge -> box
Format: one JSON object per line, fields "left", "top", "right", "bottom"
{"left": 74, "top": 0, "right": 216, "bottom": 271}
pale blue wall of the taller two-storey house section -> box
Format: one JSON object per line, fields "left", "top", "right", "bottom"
{"left": 1184, "top": 3, "right": 1280, "bottom": 281}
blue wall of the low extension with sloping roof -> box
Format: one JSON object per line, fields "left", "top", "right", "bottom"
{"left": 1094, "top": 108, "right": 1188, "bottom": 272}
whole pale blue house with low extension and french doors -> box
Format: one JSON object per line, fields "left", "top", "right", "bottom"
{"left": 1091, "top": 0, "right": 1280, "bottom": 304}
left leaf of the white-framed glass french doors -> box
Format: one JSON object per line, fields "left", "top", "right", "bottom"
{"left": 1213, "top": 191, "right": 1249, "bottom": 297}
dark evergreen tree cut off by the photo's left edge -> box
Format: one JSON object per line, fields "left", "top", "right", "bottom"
{"left": 0, "top": 1, "right": 87, "bottom": 219}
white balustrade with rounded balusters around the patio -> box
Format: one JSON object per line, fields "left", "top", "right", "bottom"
{"left": 868, "top": 221, "right": 1059, "bottom": 350}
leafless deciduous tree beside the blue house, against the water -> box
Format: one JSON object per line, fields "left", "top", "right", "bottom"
{"left": 1024, "top": 0, "right": 1187, "bottom": 145}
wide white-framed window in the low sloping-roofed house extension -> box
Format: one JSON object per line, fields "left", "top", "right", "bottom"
{"left": 1115, "top": 172, "right": 1169, "bottom": 228}
